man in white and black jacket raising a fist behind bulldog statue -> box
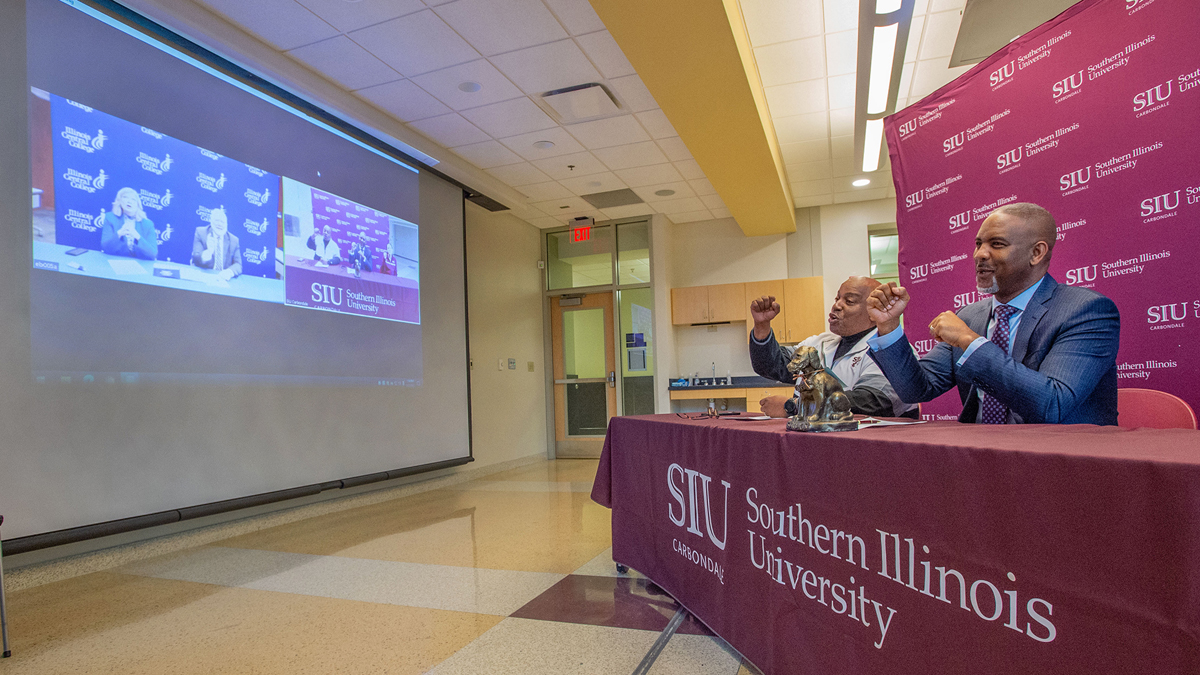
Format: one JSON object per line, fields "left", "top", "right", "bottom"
{"left": 750, "top": 276, "right": 917, "bottom": 419}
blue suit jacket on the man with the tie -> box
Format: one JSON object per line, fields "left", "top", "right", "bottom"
{"left": 871, "top": 274, "right": 1121, "bottom": 424}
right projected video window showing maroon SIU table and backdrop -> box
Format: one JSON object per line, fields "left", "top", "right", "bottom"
{"left": 283, "top": 178, "right": 421, "bottom": 323}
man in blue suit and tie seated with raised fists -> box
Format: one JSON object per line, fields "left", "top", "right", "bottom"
{"left": 868, "top": 203, "right": 1121, "bottom": 425}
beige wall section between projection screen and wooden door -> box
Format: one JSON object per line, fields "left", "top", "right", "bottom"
{"left": 467, "top": 202, "right": 546, "bottom": 467}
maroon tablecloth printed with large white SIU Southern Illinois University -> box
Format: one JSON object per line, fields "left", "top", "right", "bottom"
{"left": 592, "top": 414, "right": 1200, "bottom": 675}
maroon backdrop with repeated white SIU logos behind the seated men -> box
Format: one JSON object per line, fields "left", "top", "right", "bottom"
{"left": 886, "top": 0, "right": 1200, "bottom": 419}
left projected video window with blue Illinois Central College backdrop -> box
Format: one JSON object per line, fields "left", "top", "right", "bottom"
{"left": 43, "top": 92, "right": 283, "bottom": 284}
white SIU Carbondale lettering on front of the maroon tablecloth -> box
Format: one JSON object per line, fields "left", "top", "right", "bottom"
{"left": 667, "top": 464, "right": 730, "bottom": 584}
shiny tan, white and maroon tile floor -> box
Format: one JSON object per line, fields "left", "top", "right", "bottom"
{"left": 0, "top": 460, "right": 752, "bottom": 675}
